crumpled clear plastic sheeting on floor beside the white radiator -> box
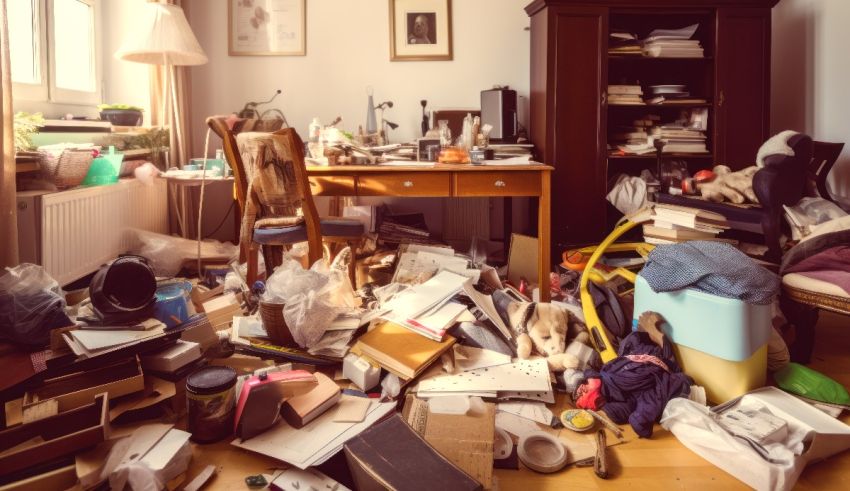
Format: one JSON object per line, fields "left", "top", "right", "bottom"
{"left": 135, "top": 230, "right": 239, "bottom": 277}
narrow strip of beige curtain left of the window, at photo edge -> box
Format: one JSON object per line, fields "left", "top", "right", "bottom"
{"left": 0, "top": 0, "right": 18, "bottom": 274}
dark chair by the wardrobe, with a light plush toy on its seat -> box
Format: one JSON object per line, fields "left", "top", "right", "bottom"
{"left": 658, "top": 135, "right": 844, "bottom": 263}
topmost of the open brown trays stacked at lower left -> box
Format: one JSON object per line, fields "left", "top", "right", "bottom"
{"left": 24, "top": 357, "right": 145, "bottom": 413}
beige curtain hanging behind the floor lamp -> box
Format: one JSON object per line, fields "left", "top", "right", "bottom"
{"left": 149, "top": 0, "right": 192, "bottom": 166}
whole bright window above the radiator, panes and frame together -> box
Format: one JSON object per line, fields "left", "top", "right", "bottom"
{"left": 6, "top": 0, "right": 100, "bottom": 105}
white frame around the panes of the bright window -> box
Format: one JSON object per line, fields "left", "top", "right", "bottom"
{"left": 12, "top": 0, "right": 103, "bottom": 107}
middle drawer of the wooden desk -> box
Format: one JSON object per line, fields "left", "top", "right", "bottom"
{"left": 357, "top": 172, "right": 451, "bottom": 197}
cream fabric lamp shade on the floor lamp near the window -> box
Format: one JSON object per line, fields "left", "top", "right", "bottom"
{"left": 115, "top": 2, "right": 207, "bottom": 66}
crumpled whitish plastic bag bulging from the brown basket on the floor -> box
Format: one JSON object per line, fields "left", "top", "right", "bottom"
{"left": 263, "top": 257, "right": 356, "bottom": 349}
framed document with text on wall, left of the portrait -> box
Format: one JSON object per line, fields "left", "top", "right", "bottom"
{"left": 227, "top": 0, "right": 307, "bottom": 56}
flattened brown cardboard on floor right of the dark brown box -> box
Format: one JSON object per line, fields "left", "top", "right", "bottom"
{"left": 404, "top": 396, "right": 496, "bottom": 488}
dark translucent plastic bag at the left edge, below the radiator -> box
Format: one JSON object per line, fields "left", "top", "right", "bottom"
{"left": 0, "top": 263, "right": 74, "bottom": 346}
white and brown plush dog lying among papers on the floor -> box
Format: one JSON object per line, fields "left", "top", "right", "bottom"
{"left": 508, "top": 302, "right": 589, "bottom": 372}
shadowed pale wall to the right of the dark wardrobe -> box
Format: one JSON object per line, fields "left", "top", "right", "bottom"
{"left": 771, "top": 0, "right": 850, "bottom": 204}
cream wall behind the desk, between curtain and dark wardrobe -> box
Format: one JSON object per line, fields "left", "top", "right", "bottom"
{"left": 184, "top": 0, "right": 530, "bottom": 243}
